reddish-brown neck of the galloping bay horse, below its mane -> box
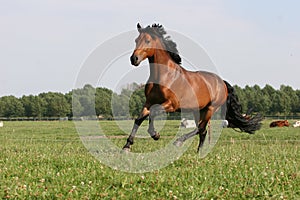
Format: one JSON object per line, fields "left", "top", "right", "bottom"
{"left": 148, "top": 50, "right": 181, "bottom": 83}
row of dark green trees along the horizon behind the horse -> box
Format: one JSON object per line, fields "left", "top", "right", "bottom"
{"left": 0, "top": 83, "right": 300, "bottom": 119}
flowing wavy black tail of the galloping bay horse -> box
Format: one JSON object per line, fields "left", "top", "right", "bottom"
{"left": 224, "top": 81, "right": 263, "bottom": 134}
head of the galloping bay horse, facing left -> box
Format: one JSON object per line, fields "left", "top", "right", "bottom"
{"left": 130, "top": 24, "right": 159, "bottom": 66}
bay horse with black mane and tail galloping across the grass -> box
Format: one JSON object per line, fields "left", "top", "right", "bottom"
{"left": 123, "top": 24, "right": 262, "bottom": 151}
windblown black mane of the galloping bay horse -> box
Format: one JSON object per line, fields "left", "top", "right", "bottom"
{"left": 140, "top": 24, "right": 181, "bottom": 64}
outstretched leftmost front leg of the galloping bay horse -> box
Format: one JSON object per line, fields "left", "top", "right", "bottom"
{"left": 123, "top": 106, "right": 150, "bottom": 151}
